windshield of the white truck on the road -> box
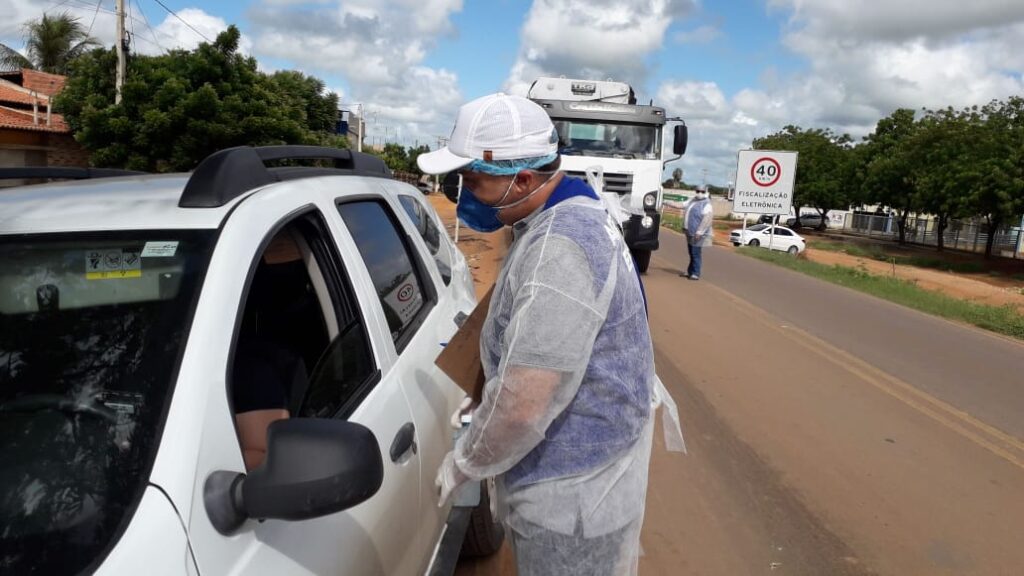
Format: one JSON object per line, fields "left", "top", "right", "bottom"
{"left": 554, "top": 120, "right": 662, "bottom": 160}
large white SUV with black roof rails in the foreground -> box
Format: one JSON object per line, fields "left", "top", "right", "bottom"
{"left": 0, "top": 147, "right": 502, "bottom": 575}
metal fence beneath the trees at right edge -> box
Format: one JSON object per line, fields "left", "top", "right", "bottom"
{"left": 843, "top": 212, "right": 1021, "bottom": 258}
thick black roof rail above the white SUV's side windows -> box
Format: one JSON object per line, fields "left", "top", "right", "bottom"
{"left": 178, "top": 146, "right": 391, "bottom": 208}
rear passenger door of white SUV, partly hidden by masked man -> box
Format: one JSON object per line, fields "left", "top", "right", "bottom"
{"left": 338, "top": 190, "right": 461, "bottom": 571}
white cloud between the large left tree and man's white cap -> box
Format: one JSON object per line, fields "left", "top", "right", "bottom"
{"left": 249, "top": 0, "right": 463, "bottom": 143}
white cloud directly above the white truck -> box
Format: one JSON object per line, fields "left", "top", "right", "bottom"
{"left": 506, "top": 0, "right": 695, "bottom": 94}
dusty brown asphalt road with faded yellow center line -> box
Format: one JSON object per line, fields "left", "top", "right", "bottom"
{"left": 459, "top": 231, "right": 1024, "bottom": 576}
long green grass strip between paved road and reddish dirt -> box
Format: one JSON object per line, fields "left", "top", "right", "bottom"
{"left": 737, "top": 247, "right": 1024, "bottom": 339}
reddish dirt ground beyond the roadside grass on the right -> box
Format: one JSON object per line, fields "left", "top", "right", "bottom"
{"left": 716, "top": 222, "right": 1024, "bottom": 314}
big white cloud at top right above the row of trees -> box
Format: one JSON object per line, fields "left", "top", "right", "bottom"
{"left": 658, "top": 0, "right": 1024, "bottom": 183}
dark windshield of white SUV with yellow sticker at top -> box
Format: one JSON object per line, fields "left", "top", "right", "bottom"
{"left": 0, "top": 231, "right": 214, "bottom": 574}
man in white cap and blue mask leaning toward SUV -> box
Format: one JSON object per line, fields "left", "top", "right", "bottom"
{"left": 418, "top": 94, "right": 655, "bottom": 576}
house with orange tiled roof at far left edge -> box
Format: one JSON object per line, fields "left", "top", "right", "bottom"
{"left": 0, "top": 69, "right": 89, "bottom": 176}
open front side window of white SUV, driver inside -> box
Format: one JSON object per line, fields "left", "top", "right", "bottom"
{"left": 231, "top": 214, "right": 377, "bottom": 424}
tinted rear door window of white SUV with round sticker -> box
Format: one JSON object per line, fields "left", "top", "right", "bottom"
{"left": 338, "top": 200, "right": 434, "bottom": 351}
